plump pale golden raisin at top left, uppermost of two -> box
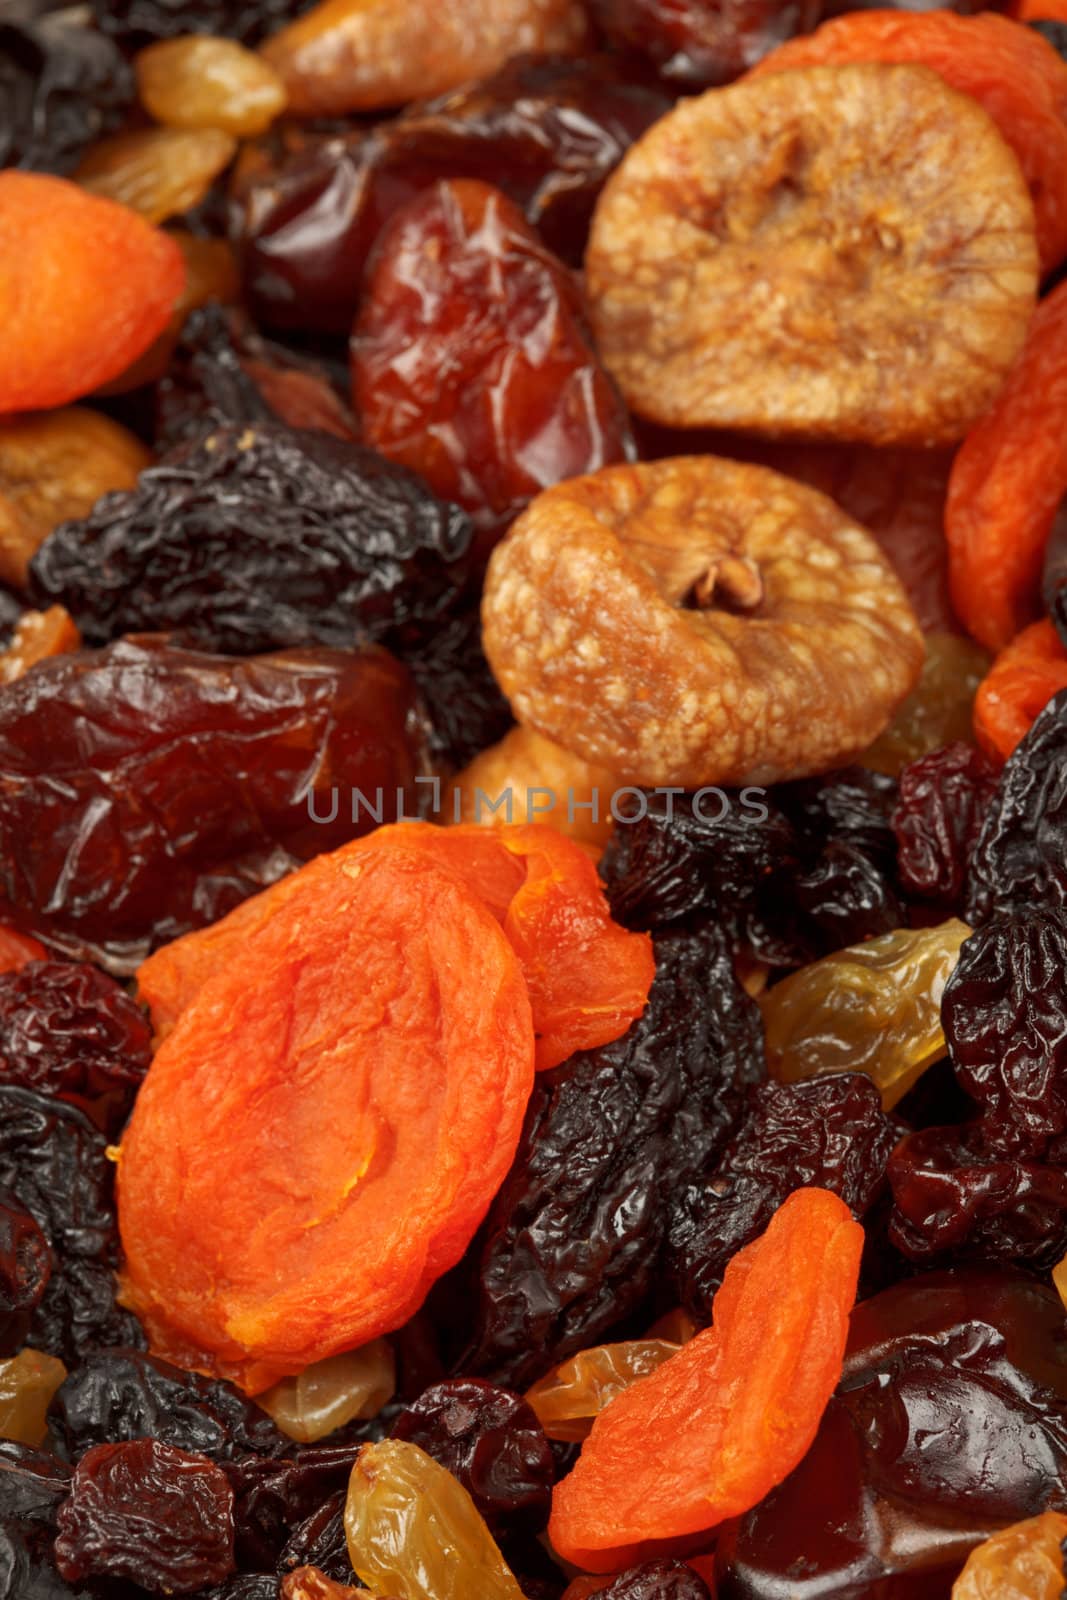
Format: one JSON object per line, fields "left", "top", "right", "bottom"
{"left": 134, "top": 34, "right": 286, "bottom": 139}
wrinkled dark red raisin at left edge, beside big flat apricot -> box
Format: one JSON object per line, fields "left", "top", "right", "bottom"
{"left": 0, "top": 962, "right": 152, "bottom": 1136}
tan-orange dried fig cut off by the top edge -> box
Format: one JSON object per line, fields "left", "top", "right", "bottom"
{"left": 262, "top": 0, "right": 589, "bottom": 117}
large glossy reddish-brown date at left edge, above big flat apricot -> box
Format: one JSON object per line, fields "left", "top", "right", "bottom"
{"left": 0, "top": 635, "right": 424, "bottom": 971}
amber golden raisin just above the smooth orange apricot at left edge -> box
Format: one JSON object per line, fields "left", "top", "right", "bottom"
{"left": 74, "top": 128, "right": 237, "bottom": 222}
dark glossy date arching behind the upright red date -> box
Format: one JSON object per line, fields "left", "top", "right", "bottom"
{"left": 235, "top": 56, "right": 670, "bottom": 338}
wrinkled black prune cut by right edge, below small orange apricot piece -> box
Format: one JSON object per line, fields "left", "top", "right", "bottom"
{"left": 966, "top": 690, "right": 1067, "bottom": 925}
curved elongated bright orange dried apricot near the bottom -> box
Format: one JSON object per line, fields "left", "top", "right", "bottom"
{"left": 549, "top": 1189, "right": 864, "bottom": 1573}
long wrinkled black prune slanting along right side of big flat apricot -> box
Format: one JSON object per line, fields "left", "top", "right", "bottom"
{"left": 461, "top": 925, "right": 763, "bottom": 1387}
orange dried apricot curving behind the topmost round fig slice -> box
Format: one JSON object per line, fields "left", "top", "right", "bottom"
{"left": 753, "top": 10, "right": 1067, "bottom": 270}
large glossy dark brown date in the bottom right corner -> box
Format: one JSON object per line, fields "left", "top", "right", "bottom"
{"left": 715, "top": 1269, "right": 1067, "bottom": 1600}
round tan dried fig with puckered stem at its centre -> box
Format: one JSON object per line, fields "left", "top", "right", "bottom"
{"left": 482, "top": 456, "right": 923, "bottom": 789}
